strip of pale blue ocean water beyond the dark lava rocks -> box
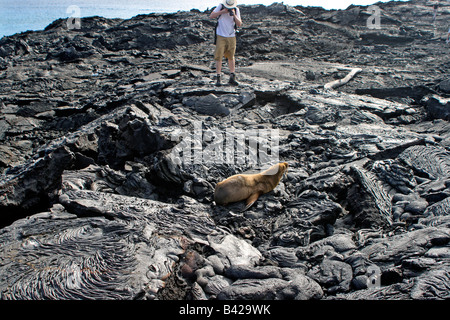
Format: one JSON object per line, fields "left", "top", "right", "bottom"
{"left": 0, "top": 0, "right": 408, "bottom": 38}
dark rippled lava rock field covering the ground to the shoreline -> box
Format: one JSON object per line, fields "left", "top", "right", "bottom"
{"left": 0, "top": 0, "right": 450, "bottom": 300}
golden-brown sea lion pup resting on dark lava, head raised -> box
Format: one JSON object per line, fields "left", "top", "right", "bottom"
{"left": 214, "top": 162, "right": 288, "bottom": 211}
